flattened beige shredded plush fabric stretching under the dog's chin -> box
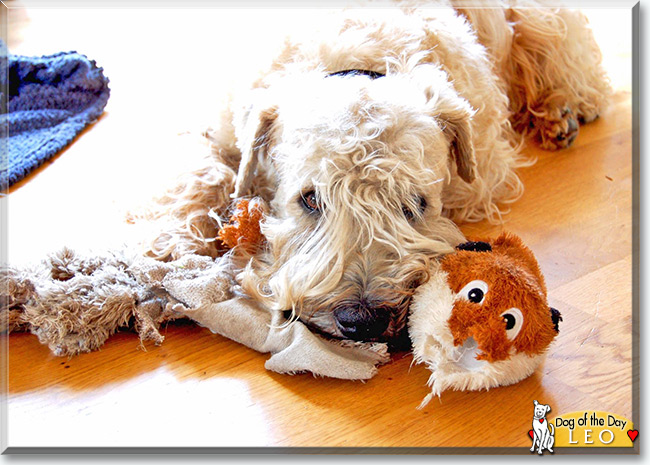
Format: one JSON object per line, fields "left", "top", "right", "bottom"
{"left": 0, "top": 249, "right": 390, "bottom": 380}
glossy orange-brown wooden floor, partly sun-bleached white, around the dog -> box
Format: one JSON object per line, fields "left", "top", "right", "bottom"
{"left": 1, "top": 3, "right": 633, "bottom": 450}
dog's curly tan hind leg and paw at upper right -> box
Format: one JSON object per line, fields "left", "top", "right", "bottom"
{"left": 504, "top": 8, "right": 611, "bottom": 150}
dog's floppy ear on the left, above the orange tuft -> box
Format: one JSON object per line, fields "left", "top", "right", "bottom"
{"left": 233, "top": 95, "right": 278, "bottom": 198}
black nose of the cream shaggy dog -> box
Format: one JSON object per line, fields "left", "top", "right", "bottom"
{"left": 334, "top": 303, "right": 390, "bottom": 341}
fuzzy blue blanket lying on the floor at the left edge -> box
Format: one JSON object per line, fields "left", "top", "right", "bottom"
{"left": 0, "top": 52, "right": 110, "bottom": 191}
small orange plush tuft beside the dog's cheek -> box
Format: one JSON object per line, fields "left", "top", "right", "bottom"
{"left": 217, "top": 197, "right": 267, "bottom": 255}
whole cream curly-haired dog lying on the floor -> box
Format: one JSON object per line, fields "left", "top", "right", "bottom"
{"left": 140, "top": 2, "right": 609, "bottom": 341}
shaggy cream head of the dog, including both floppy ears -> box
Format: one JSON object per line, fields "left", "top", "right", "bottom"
{"left": 236, "top": 66, "right": 474, "bottom": 341}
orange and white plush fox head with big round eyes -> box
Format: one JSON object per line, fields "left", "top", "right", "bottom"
{"left": 409, "top": 234, "right": 562, "bottom": 407}
